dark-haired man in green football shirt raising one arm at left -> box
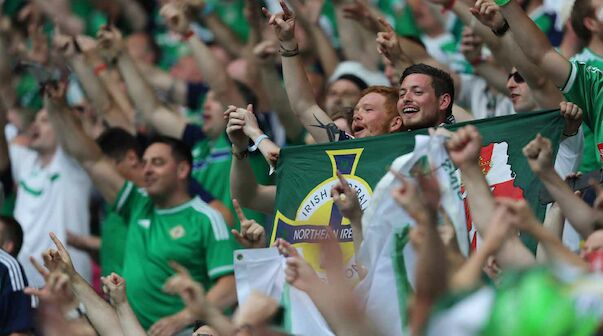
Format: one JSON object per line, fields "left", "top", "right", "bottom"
{"left": 45, "top": 85, "right": 236, "bottom": 335}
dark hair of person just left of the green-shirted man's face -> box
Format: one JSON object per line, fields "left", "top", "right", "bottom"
{"left": 96, "top": 127, "right": 142, "bottom": 162}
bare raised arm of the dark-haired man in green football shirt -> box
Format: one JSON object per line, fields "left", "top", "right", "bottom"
{"left": 44, "top": 83, "right": 125, "bottom": 204}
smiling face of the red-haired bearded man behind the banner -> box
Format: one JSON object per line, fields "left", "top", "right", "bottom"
{"left": 352, "top": 92, "right": 402, "bottom": 138}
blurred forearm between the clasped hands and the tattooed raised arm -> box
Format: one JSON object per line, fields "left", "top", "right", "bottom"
{"left": 260, "top": 63, "right": 303, "bottom": 140}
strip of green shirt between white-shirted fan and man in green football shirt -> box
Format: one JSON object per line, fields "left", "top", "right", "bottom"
{"left": 99, "top": 210, "right": 128, "bottom": 276}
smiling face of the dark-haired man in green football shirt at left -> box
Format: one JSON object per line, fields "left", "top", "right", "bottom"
{"left": 142, "top": 143, "right": 190, "bottom": 198}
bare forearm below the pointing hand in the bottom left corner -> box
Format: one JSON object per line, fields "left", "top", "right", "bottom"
{"left": 71, "top": 273, "right": 124, "bottom": 335}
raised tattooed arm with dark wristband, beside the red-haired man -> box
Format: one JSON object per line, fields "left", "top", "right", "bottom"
{"left": 263, "top": 0, "right": 340, "bottom": 143}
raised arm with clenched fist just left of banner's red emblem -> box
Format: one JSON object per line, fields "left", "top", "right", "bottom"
{"left": 447, "top": 126, "right": 534, "bottom": 266}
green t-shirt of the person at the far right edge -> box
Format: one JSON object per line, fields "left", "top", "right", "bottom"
{"left": 561, "top": 60, "right": 603, "bottom": 169}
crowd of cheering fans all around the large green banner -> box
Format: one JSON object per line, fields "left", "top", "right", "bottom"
{"left": 0, "top": 0, "right": 603, "bottom": 336}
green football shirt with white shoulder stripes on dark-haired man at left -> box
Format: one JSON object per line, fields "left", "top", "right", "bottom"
{"left": 113, "top": 182, "right": 235, "bottom": 329}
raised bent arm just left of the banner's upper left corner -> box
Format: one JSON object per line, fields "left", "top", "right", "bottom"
{"left": 225, "top": 106, "right": 276, "bottom": 215}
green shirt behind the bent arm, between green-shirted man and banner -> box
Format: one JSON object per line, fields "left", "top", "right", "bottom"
{"left": 192, "top": 132, "right": 270, "bottom": 229}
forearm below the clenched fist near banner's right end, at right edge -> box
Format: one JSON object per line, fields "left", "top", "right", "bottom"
{"left": 539, "top": 168, "right": 603, "bottom": 238}
